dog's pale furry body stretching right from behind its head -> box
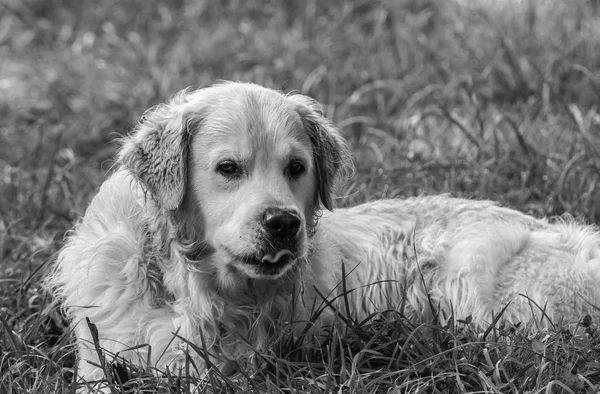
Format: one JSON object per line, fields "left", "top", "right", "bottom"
{"left": 322, "top": 196, "right": 600, "bottom": 327}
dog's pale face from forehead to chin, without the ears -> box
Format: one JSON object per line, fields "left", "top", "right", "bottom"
{"left": 189, "top": 91, "right": 317, "bottom": 277}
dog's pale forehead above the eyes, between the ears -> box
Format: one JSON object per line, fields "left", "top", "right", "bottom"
{"left": 194, "top": 91, "right": 312, "bottom": 165}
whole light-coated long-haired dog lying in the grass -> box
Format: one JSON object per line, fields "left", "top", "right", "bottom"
{"left": 49, "top": 82, "right": 600, "bottom": 388}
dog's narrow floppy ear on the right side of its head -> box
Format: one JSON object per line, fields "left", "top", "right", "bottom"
{"left": 288, "top": 94, "right": 352, "bottom": 210}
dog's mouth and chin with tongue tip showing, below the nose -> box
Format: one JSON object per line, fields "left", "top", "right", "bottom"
{"left": 232, "top": 250, "right": 298, "bottom": 279}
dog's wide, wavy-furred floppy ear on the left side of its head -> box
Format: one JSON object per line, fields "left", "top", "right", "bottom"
{"left": 118, "top": 92, "right": 190, "bottom": 210}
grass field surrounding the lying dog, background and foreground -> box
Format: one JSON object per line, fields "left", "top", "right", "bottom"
{"left": 0, "top": 0, "right": 600, "bottom": 393}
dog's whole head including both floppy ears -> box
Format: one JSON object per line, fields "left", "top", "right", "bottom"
{"left": 119, "top": 83, "right": 349, "bottom": 281}
